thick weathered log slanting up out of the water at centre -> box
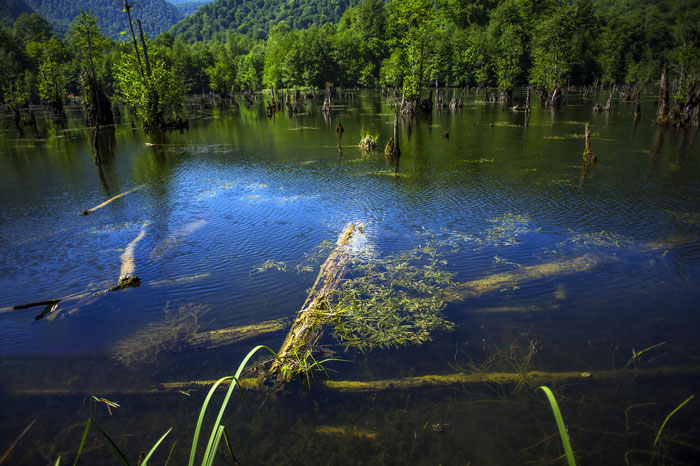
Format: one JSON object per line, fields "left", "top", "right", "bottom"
{"left": 270, "top": 223, "right": 363, "bottom": 379}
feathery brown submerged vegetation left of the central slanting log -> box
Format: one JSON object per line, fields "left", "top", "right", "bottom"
{"left": 112, "top": 304, "right": 209, "bottom": 365}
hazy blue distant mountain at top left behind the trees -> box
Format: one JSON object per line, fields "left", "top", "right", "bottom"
{"left": 23, "top": 0, "right": 182, "bottom": 38}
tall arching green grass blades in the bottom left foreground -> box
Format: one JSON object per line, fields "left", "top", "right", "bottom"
{"left": 54, "top": 345, "right": 277, "bottom": 466}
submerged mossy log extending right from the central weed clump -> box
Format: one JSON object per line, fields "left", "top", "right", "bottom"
{"left": 443, "top": 255, "right": 600, "bottom": 302}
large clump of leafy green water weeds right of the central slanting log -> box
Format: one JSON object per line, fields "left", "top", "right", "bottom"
{"left": 330, "top": 238, "right": 454, "bottom": 352}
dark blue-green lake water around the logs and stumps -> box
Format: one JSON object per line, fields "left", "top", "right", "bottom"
{"left": 0, "top": 91, "right": 700, "bottom": 465}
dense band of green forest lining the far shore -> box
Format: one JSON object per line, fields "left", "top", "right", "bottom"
{"left": 0, "top": 0, "right": 700, "bottom": 128}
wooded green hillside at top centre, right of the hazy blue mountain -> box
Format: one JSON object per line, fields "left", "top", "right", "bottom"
{"left": 170, "top": 0, "right": 359, "bottom": 42}
